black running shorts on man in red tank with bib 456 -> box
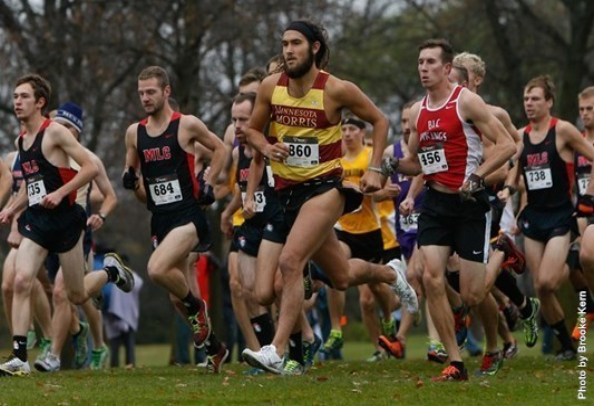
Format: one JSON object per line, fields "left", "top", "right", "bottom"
{"left": 417, "top": 188, "right": 491, "bottom": 263}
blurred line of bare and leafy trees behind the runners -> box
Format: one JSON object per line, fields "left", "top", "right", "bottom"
{"left": 0, "top": 0, "right": 594, "bottom": 342}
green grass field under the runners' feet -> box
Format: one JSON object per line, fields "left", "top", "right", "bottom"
{"left": 0, "top": 335, "right": 594, "bottom": 406}
